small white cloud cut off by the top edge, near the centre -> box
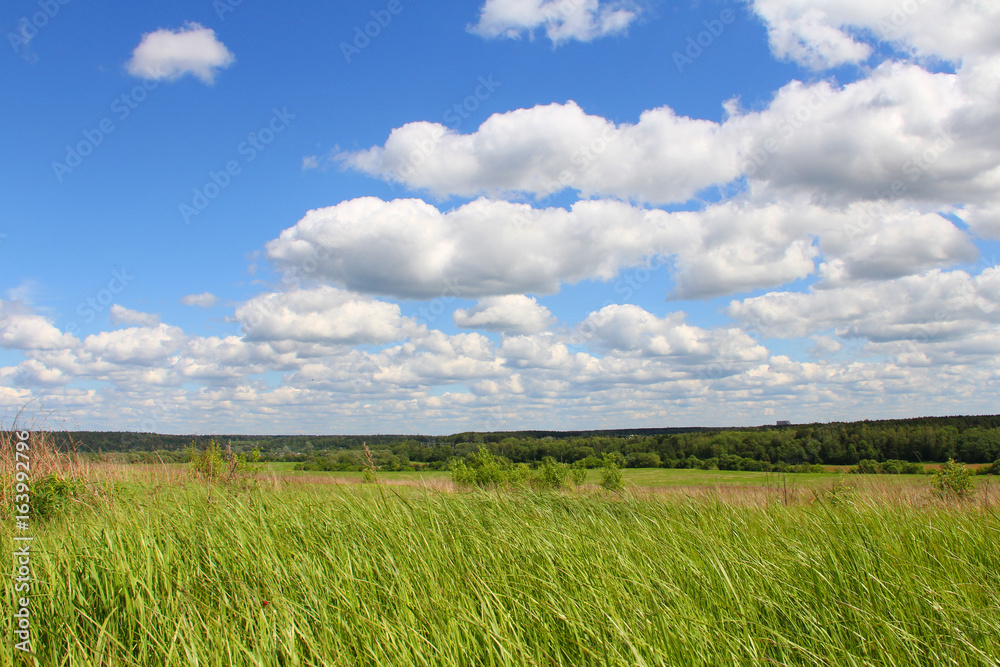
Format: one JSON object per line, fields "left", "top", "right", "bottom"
{"left": 469, "top": 0, "right": 639, "bottom": 44}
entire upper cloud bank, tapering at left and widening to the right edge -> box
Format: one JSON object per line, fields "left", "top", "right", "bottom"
{"left": 337, "top": 58, "right": 1000, "bottom": 211}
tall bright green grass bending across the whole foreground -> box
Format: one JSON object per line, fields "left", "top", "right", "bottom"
{"left": 0, "top": 471, "right": 1000, "bottom": 667}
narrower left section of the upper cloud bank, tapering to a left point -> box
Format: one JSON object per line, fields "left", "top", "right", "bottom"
{"left": 338, "top": 102, "right": 740, "bottom": 203}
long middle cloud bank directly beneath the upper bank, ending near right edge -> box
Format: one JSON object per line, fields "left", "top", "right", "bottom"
{"left": 267, "top": 198, "right": 977, "bottom": 302}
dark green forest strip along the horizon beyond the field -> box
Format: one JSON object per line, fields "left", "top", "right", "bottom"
{"left": 37, "top": 415, "right": 1000, "bottom": 470}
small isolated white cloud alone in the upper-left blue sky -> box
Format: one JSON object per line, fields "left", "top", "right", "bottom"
{"left": 127, "top": 23, "right": 236, "bottom": 84}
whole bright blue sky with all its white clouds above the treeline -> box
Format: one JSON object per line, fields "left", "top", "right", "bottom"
{"left": 0, "top": 0, "right": 1000, "bottom": 434}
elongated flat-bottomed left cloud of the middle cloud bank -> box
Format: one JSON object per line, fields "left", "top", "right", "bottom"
{"left": 267, "top": 197, "right": 689, "bottom": 299}
